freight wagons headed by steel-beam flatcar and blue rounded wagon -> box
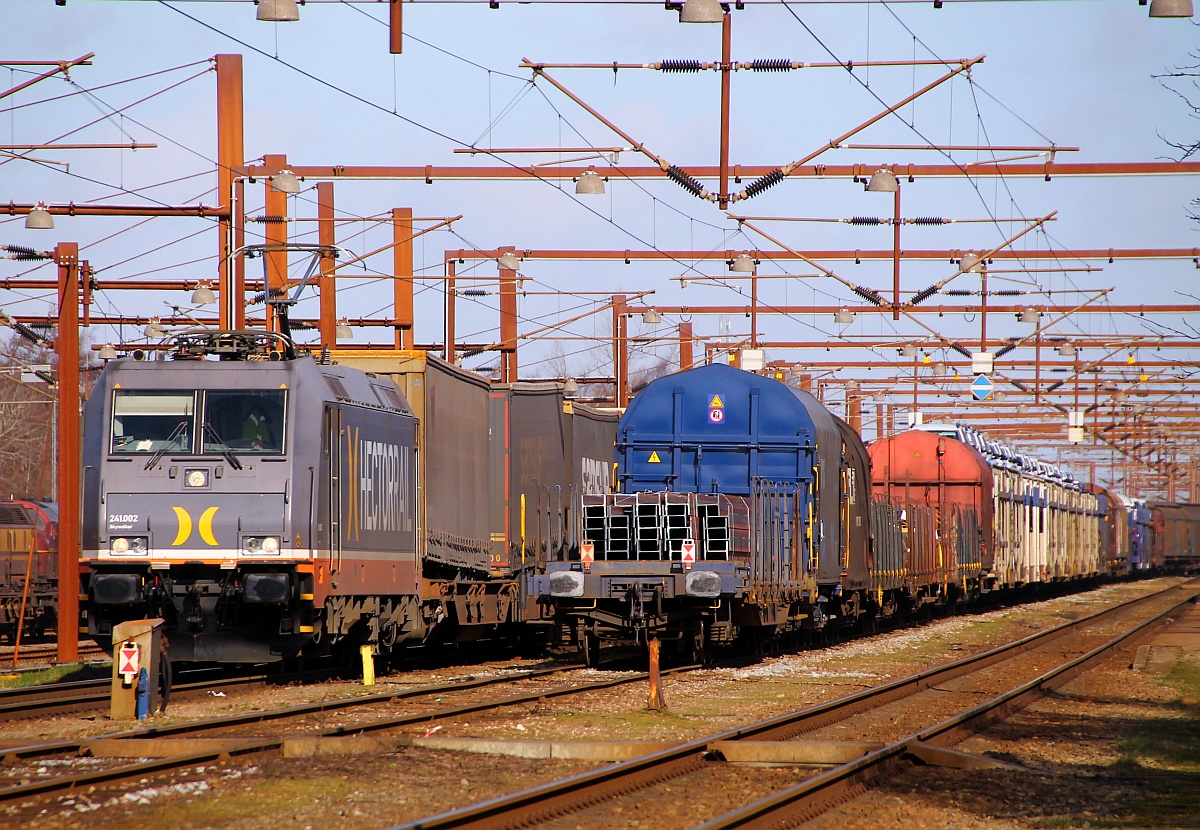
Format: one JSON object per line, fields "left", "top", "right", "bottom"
{"left": 526, "top": 365, "right": 1200, "bottom": 662}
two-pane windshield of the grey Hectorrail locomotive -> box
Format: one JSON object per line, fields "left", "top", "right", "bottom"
{"left": 112, "top": 390, "right": 286, "bottom": 455}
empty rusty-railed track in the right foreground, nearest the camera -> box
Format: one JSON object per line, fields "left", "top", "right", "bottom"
{"left": 391, "top": 587, "right": 1195, "bottom": 830}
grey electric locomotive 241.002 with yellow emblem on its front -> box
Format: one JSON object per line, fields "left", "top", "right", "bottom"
{"left": 80, "top": 331, "right": 417, "bottom": 662}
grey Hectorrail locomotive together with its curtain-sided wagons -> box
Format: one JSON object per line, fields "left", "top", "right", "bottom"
{"left": 80, "top": 330, "right": 617, "bottom": 662}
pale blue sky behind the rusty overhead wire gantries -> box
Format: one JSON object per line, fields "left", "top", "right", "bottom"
{"left": 0, "top": 0, "right": 1200, "bottom": 422}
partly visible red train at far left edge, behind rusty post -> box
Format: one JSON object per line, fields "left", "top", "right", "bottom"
{"left": 0, "top": 499, "right": 59, "bottom": 642}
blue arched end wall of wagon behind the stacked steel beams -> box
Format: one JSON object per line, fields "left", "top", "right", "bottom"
{"left": 617, "top": 363, "right": 820, "bottom": 495}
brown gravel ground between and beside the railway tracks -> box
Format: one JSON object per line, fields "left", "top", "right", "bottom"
{"left": 0, "top": 579, "right": 1200, "bottom": 830}
